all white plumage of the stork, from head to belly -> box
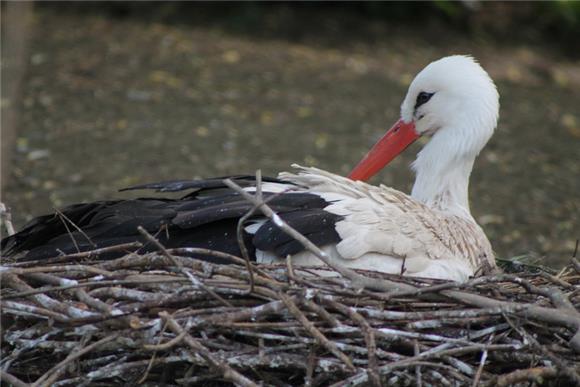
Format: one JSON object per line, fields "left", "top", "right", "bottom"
{"left": 258, "top": 56, "right": 499, "bottom": 281}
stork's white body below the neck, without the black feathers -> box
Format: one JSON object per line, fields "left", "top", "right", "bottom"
{"left": 270, "top": 168, "right": 495, "bottom": 281}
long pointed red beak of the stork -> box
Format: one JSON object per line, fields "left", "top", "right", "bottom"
{"left": 348, "top": 120, "right": 419, "bottom": 181}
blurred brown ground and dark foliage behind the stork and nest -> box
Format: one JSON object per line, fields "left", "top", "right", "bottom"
{"left": 1, "top": 1, "right": 580, "bottom": 266}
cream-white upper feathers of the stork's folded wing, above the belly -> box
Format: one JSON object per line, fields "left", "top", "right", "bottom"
{"left": 279, "top": 165, "right": 493, "bottom": 271}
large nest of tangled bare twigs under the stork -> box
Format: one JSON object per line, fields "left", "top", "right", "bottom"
{"left": 0, "top": 244, "right": 580, "bottom": 386}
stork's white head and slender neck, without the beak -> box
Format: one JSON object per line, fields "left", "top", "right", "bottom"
{"left": 401, "top": 55, "right": 499, "bottom": 220}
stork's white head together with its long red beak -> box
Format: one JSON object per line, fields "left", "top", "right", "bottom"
{"left": 350, "top": 55, "right": 499, "bottom": 180}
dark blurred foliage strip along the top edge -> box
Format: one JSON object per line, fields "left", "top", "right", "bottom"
{"left": 44, "top": 0, "right": 580, "bottom": 55}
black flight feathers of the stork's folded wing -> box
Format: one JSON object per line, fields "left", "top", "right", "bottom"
{"left": 1, "top": 175, "right": 342, "bottom": 262}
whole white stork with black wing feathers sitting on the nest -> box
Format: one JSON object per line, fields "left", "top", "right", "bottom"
{"left": 2, "top": 56, "right": 499, "bottom": 281}
